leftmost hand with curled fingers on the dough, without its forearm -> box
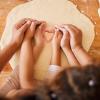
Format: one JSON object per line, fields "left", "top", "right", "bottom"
{"left": 11, "top": 19, "right": 30, "bottom": 48}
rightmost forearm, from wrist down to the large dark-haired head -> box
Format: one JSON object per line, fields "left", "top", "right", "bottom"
{"left": 73, "top": 47, "right": 94, "bottom": 66}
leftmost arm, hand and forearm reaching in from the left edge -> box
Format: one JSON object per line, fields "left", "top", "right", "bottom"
{"left": 0, "top": 19, "right": 29, "bottom": 71}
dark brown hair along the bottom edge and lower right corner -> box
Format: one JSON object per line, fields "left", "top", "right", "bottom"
{"left": 1, "top": 65, "right": 100, "bottom": 100}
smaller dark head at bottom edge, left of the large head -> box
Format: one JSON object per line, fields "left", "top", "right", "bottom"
{"left": 10, "top": 86, "right": 51, "bottom": 100}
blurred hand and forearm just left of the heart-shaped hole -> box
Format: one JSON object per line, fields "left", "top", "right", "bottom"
{"left": 33, "top": 22, "right": 46, "bottom": 62}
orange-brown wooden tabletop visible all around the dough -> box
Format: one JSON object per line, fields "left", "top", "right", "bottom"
{"left": 0, "top": 0, "right": 100, "bottom": 84}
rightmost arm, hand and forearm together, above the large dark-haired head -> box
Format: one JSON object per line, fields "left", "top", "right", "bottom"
{"left": 62, "top": 25, "right": 95, "bottom": 66}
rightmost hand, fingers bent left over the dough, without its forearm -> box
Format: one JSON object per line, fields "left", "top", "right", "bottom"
{"left": 59, "top": 25, "right": 82, "bottom": 50}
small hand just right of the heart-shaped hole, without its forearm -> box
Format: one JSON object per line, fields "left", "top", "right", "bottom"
{"left": 52, "top": 29, "right": 62, "bottom": 49}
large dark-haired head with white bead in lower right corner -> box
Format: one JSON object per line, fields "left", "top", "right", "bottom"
{"left": 51, "top": 65, "right": 100, "bottom": 100}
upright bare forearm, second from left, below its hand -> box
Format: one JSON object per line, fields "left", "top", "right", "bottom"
{"left": 20, "top": 40, "right": 34, "bottom": 89}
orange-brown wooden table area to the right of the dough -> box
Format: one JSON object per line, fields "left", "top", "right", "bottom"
{"left": 71, "top": 0, "right": 100, "bottom": 62}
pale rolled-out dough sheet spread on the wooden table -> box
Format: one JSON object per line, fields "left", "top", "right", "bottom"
{"left": 1, "top": 0, "right": 95, "bottom": 80}
